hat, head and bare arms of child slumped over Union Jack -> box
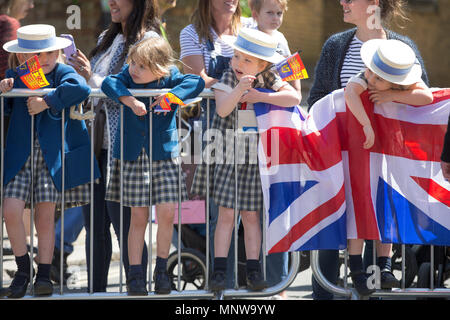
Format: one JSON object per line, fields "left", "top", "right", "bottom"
{"left": 345, "top": 39, "right": 433, "bottom": 149}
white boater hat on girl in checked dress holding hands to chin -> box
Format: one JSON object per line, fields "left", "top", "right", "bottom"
{"left": 225, "top": 28, "right": 284, "bottom": 63}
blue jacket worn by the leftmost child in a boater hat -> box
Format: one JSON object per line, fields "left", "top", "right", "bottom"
{"left": 3, "top": 64, "right": 100, "bottom": 192}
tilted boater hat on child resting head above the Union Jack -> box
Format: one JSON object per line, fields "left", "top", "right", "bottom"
{"left": 361, "top": 39, "right": 422, "bottom": 85}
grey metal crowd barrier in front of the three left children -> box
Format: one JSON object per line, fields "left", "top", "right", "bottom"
{"left": 0, "top": 89, "right": 299, "bottom": 299}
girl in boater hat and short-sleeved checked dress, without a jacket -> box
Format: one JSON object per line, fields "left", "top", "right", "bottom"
{"left": 192, "top": 28, "right": 300, "bottom": 292}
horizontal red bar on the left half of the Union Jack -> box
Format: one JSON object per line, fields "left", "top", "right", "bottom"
{"left": 261, "top": 120, "right": 342, "bottom": 171}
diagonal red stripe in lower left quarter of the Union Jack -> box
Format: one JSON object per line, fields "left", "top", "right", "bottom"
{"left": 269, "top": 185, "right": 345, "bottom": 253}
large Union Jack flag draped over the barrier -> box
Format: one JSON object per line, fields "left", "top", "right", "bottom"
{"left": 255, "top": 89, "right": 450, "bottom": 253}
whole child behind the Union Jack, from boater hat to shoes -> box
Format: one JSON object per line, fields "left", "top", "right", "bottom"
{"left": 345, "top": 39, "right": 433, "bottom": 296}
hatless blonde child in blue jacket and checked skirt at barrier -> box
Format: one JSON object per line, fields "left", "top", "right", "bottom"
{"left": 102, "top": 38, "right": 205, "bottom": 295}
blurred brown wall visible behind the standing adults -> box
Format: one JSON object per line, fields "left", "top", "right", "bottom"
{"left": 22, "top": 0, "right": 450, "bottom": 89}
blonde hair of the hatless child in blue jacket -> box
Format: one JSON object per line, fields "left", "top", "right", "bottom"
{"left": 127, "top": 38, "right": 175, "bottom": 78}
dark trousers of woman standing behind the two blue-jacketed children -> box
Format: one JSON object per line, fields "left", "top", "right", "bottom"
{"left": 83, "top": 150, "right": 148, "bottom": 292}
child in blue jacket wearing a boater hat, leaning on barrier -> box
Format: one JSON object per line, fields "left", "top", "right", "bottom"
{"left": 0, "top": 25, "right": 99, "bottom": 298}
